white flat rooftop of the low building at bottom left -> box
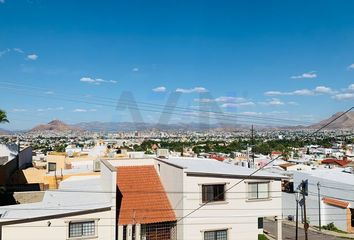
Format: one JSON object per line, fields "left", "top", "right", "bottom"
{"left": 0, "top": 176, "right": 111, "bottom": 222}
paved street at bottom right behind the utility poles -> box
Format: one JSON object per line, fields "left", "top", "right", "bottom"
{"left": 264, "top": 219, "right": 343, "bottom": 240}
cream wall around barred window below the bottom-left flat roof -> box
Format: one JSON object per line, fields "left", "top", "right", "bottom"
{"left": 1, "top": 211, "right": 115, "bottom": 240}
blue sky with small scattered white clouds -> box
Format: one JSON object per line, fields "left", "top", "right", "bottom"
{"left": 0, "top": 0, "right": 354, "bottom": 129}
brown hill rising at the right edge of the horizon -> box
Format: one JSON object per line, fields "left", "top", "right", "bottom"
{"left": 308, "top": 112, "right": 354, "bottom": 129}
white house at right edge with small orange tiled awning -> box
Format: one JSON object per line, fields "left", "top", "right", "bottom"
{"left": 283, "top": 168, "right": 354, "bottom": 232}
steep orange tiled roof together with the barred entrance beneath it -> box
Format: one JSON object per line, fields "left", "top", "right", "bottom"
{"left": 117, "top": 165, "right": 176, "bottom": 240}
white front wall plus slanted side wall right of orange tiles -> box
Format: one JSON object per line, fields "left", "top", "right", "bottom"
{"left": 157, "top": 158, "right": 282, "bottom": 240}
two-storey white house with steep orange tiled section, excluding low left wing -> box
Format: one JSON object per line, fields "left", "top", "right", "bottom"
{"left": 107, "top": 157, "right": 282, "bottom": 240}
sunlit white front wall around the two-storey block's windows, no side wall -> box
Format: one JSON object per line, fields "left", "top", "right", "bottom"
{"left": 183, "top": 176, "right": 282, "bottom": 240}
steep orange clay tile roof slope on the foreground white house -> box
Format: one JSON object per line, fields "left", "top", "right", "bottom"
{"left": 117, "top": 166, "right": 176, "bottom": 225}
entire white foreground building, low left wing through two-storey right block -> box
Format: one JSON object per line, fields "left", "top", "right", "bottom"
{"left": 0, "top": 157, "right": 282, "bottom": 240}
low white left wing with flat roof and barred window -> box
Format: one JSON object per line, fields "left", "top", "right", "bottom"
{"left": 0, "top": 159, "right": 116, "bottom": 240}
